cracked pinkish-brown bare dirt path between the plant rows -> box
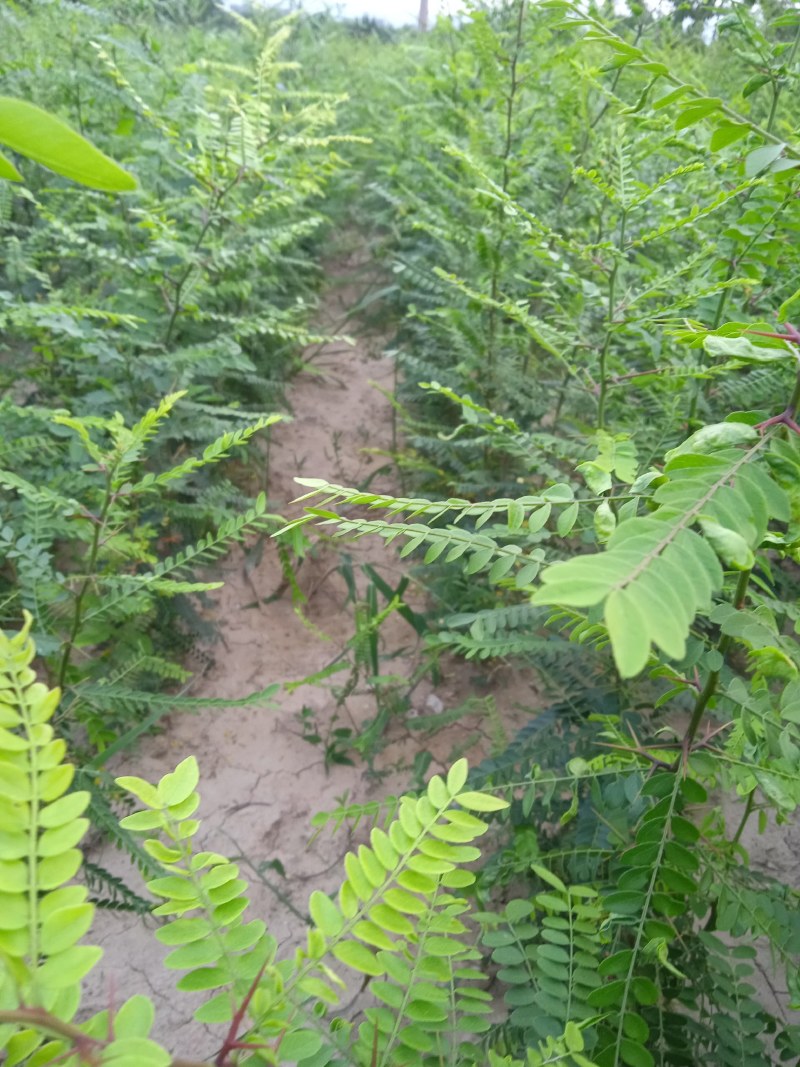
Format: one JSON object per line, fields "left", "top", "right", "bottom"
{"left": 84, "top": 235, "right": 538, "bottom": 1058}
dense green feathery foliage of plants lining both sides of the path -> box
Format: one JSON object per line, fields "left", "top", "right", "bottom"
{"left": 0, "top": 0, "right": 800, "bottom": 1067}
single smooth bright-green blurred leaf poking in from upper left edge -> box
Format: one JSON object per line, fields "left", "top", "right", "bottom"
{"left": 0, "top": 96, "right": 137, "bottom": 192}
